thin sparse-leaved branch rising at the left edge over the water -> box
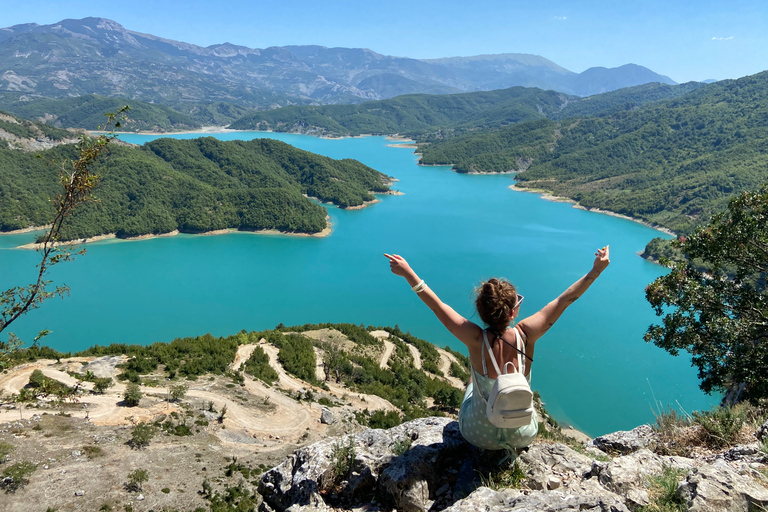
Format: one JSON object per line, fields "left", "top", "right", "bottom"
{"left": 0, "top": 107, "right": 128, "bottom": 368}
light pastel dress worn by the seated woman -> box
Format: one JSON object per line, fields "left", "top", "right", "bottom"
{"left": 459, "top": 329, "right": 539, "bottom": 450}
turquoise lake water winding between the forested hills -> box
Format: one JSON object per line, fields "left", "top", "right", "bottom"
{"left": 0, "top": 132, "right": 717, "bottom": 436}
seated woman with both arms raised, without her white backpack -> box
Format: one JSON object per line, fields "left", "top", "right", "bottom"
{"left": 384, "top": 246, "right": 610, "bottom": 450}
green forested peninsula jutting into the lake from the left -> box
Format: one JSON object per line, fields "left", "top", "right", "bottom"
{"left": 0, "top": 137, "right": 388, "bottom": 239}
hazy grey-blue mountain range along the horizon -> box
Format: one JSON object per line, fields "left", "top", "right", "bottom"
{"left": 0, "top": 18, "right": 675, "bottom": 108}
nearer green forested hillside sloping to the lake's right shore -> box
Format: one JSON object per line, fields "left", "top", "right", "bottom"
{"left": 420, "top": 72, "right": 768, "bottom": 232}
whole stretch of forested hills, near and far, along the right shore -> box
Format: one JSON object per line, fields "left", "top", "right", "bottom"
{"left": 232, "top": 72, "right": 768, "bottom": 234}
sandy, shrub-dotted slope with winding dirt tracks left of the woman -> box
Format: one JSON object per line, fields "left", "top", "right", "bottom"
{"left": 0, "top": 324, "right": 474, "bottom": 512}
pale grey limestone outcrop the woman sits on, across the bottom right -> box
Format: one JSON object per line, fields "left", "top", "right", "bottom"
{"left": 259, "top": 418, "right": 768, "bottom": 512}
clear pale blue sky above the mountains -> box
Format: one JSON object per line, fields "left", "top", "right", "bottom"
{"left": 0, "top": 0, "right": 768, "bottom": 82}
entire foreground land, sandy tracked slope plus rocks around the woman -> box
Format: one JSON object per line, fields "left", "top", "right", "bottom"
{"left": 0, "top": 324, "right": 768, "bottom": 512}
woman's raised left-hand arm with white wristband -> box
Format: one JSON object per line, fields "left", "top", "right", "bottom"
{"left": 384, "top": 254, "right": 481, "bottom": 345}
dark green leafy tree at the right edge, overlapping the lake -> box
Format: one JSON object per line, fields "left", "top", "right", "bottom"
{"left": 645, "top": 185, "right": 768, "bottom": 401}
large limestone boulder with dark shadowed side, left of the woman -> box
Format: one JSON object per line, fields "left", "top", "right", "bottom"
{"left": 259, "top": 418, "right": 477, "bottom": 512}
